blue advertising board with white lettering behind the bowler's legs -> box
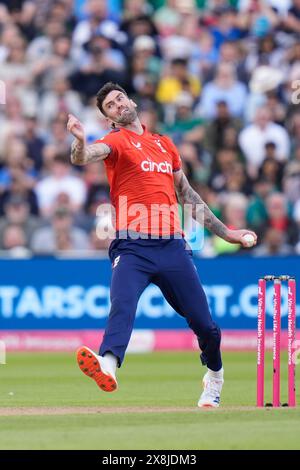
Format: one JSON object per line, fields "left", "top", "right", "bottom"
{"left": 0, "top": 256, "right": 300, "bottom": 330}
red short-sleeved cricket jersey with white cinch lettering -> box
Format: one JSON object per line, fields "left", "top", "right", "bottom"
{"left": 96, "top": 126, "right": 182, "bottom": 236}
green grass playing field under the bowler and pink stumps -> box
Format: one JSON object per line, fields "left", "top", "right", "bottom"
{"left": 0, "top": 352, "right": 300, "bottom": 450}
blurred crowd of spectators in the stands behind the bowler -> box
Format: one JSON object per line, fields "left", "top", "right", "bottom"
{"left": 0, "top": 0, "right": 300, "bottom": 256}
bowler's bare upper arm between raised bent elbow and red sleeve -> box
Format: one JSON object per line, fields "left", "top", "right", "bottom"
{"left": 71, "top": 139, "right": 110, "bottom": 165}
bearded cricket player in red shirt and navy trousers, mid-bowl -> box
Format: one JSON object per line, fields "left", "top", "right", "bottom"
{"left": 67, "top": 82, "right": 257, "bottom": 408}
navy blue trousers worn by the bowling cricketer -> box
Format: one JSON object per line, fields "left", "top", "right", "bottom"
{"left": 99, "top": 239, "right": 222, "bottom": 371}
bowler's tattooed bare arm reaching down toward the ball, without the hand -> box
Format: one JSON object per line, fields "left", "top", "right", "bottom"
{"left": 175, "top": 171, "right": 228, "bottom": 240}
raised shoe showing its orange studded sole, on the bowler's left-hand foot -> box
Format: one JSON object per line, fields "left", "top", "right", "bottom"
{"left": 77, "top": 346, "right": 118, "bottom": 392}
